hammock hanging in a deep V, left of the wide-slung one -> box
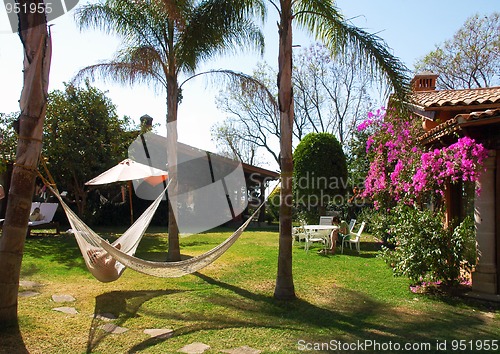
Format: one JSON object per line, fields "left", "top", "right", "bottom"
{"left": 48, "top": 181, "right": 170, "bottom": 283}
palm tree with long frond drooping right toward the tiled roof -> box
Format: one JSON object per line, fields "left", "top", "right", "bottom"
{"left": 268, "top": 0, "right": 408, "bottom": 300}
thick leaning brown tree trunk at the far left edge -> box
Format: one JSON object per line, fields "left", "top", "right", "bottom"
{"left": 0, "top": 0, "right": 51, "bottom": 327}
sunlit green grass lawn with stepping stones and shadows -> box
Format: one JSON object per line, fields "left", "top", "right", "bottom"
{"left": 0, "top": 229, "right": 500, "bottom": 353}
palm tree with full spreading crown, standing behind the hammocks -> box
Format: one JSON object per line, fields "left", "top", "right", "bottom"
{"left": 76, "top": 0, "right": 265, "bottom": 261}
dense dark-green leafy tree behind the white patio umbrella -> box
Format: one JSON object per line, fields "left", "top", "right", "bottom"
{"left": 43, "top": 82, "right": 139, "bottom": 216}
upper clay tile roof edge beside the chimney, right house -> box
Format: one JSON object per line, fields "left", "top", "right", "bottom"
{"left": 412, "top": 87, "right": 500, "bottom": 110}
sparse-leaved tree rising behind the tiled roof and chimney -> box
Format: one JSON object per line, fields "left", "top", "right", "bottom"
{"left": 415, "top": 12, "right": 500, "bottom": 90}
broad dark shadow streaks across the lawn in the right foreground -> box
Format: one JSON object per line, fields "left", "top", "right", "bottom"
{"left": 115, "top": 273, "right": 499, "bottom": 353}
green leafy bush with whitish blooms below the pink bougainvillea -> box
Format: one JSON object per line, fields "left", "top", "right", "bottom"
{"left": 381, "top": 206, "right": 476, "bottom": 284}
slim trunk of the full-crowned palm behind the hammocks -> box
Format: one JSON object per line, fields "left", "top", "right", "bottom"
{"left": 167, "top": 76, "right": 181, "bottom": 262}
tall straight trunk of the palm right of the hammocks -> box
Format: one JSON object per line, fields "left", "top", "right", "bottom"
{"left": 274, "top": 0, "right": 295, "bottom": 300}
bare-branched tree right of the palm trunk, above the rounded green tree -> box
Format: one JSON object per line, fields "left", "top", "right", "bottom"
{"left": 293, "top": 44, "right": 372, "bottom": 146}
